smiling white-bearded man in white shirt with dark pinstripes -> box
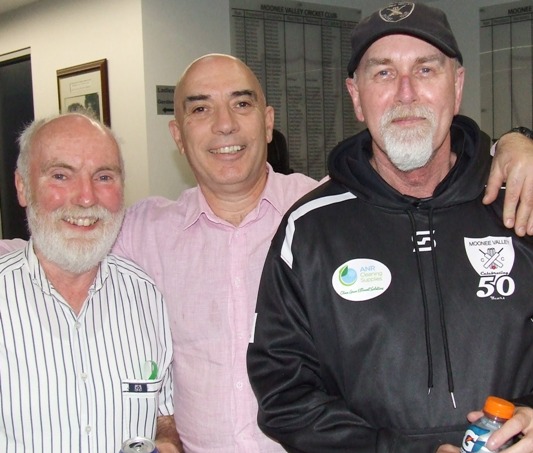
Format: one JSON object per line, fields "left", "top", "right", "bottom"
{"left": 0, "top": 113, "right": 181, "bottom": 453}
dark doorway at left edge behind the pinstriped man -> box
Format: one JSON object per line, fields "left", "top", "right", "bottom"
{"left": 0, "top": 55, "right": 34, "bottom": 239}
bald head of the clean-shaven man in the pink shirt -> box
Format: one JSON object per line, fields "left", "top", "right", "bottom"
{"left": 169, "top": 54, "right": 274, "bottom": 207}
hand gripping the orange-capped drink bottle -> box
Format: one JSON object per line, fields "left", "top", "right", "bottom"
{"left": 468, "top": 407, "right": 533, "bottom": 453}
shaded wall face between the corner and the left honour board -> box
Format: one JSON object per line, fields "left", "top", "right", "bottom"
{"left": 142, "top": 0, "right": 236, "bottom": 198}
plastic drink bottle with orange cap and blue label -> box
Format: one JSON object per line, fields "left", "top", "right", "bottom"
{"left": 461, "top": 396, "right": 514, "bottom": 453}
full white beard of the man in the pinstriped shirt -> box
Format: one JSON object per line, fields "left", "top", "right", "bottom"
{"left": 26, "top": 200, "right": 125, "bottom": 274}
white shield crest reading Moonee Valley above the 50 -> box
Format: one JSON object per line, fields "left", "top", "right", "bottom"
{"left": 464, "top": 236, "right": 515, "bottom": 276}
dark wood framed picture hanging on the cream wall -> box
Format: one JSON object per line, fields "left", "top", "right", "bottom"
{"left": 57, "top": 59, "right": 111, "bottom": 126}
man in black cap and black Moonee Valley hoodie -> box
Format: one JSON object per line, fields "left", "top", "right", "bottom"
{"left": 248, "top": 2, "right": 533, "bottom": 453}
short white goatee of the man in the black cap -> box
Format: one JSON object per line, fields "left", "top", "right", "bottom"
{"left": 380, "top": 106, "right": 436, "bottom": 172}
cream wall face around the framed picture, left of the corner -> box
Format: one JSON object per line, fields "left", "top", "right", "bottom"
{"left": 0, "top": 0, "right": 149, "bottom": 203}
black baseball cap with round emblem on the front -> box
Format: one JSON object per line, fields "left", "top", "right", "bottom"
{"left": 348, "top": 2, "right": 463, "bottom": 77}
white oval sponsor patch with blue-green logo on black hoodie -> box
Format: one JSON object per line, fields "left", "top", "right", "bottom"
{"left": 331, "top": 258, "right": 392, "bottom": 301}
